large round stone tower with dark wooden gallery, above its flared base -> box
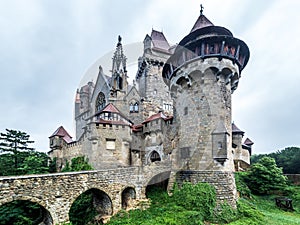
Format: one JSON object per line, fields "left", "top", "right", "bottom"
{"left": 163, "top": 7, "right": 249, "bottom": 171}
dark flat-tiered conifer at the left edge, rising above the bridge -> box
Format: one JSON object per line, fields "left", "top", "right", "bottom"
{"left": 0, "top": 129, "right": 34, "bottom": 170}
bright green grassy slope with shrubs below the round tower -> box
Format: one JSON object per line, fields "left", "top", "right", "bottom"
{"left": 108, "top": 186, "right": 300, "bottom": 225}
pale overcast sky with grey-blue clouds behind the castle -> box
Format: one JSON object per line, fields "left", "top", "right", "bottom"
{"left": 0, "top": 0, "right": 300, "bottom": 153}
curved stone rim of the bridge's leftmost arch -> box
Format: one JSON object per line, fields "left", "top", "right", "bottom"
{"left": 0, "top": 196, "right": 54, "bottom": 225}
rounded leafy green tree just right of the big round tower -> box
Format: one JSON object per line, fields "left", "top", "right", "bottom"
{"left": 245, "top": 157, "right": 287, "bottom": 194}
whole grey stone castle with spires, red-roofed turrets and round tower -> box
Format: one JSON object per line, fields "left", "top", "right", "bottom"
{"left": 49, "top": 6, "right": 253, "bottom": 192}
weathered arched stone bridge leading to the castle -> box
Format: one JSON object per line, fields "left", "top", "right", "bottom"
{"left": 0, "top": 165, "right": 170, "bottom": 224}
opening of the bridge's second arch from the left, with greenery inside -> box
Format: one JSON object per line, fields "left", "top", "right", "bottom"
{"left": 69, "top": 188, "right": 113, "bottom": 224}
